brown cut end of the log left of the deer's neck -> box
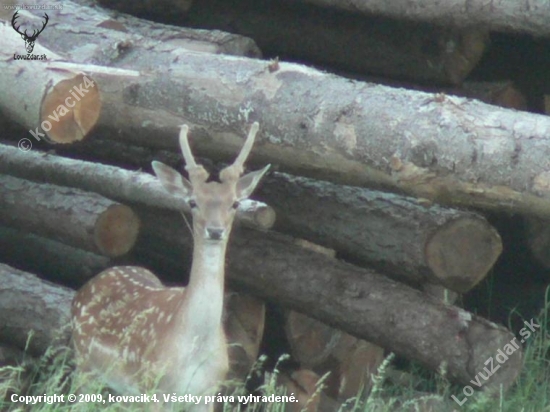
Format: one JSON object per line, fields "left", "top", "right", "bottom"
{"left": 94, "top": 204, "right": 140, "bottom": 257}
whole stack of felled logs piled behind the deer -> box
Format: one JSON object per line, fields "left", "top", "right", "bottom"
{"left": 0, "top": 0, "right": 550, "bottom": 410}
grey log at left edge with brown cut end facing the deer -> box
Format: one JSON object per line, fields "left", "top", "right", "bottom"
{"left": 0, "top": 175, "right": 139, "bottom": 256}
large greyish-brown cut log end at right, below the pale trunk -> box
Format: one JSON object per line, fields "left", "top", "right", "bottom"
{"left": 425, "top": 217, "right": 502, "bottom": 293}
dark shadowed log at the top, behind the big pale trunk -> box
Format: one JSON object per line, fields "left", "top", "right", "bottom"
{"left": 182, "top": 0, "right": 488, "bottom": 84}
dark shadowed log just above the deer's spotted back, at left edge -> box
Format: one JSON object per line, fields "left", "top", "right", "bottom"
{"left": 0, "top": 227, "right": 113, "bottom": 288}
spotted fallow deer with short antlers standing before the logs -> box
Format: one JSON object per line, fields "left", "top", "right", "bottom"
{"left": 72, "top": 123, "right": 269, "bottom": 411}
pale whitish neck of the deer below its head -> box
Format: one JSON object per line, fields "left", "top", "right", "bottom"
{"left": 184, "top": 233, "right": 227, "bottom": 337}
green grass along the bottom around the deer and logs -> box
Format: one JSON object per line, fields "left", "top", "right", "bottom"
{"left": 0, "top": 296, "right": 550, "bottom": 412}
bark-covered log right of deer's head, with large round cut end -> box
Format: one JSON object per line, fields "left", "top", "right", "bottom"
{"left": 256, "top": 173, "right": 502, "bottom": 292}
